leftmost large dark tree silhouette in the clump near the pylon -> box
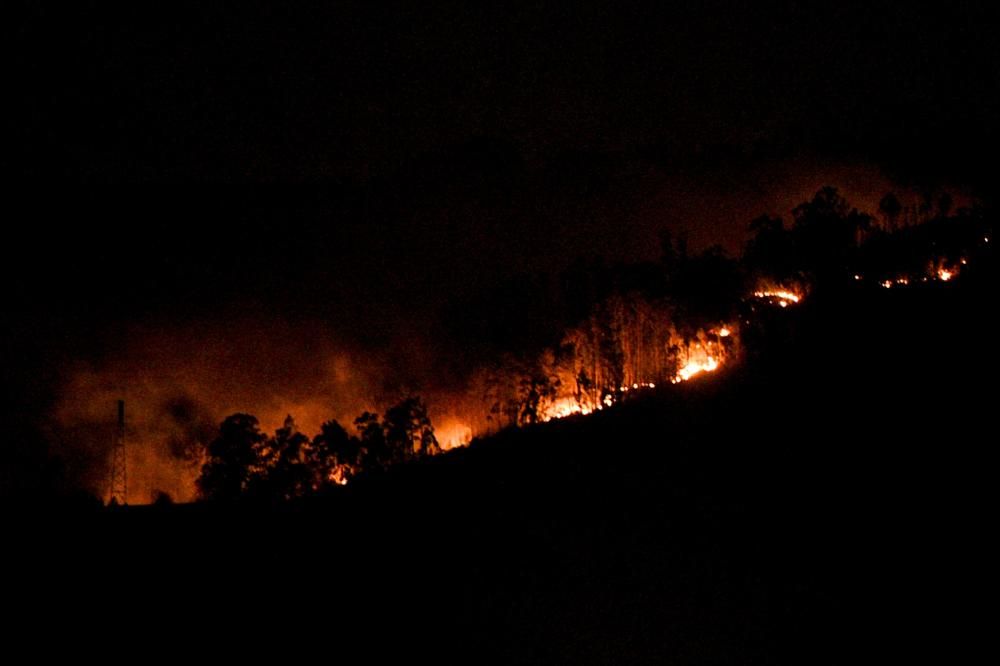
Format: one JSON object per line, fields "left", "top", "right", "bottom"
{"left": 197, "top": 414, "right": 267, "bottom": 500}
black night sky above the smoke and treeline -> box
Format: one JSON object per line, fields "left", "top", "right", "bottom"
{"left": 0, "top": 2, "right": 1000, "bottom": 496}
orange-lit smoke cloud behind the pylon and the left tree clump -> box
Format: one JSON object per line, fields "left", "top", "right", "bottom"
{"left": 52, "top": 320, "right": 388, "bottom": 503}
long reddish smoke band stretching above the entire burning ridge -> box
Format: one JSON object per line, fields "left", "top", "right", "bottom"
{"left": 43, "top": 159, "right": 967, "bottom": 503}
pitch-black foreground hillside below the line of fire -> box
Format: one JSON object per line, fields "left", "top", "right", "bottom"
{"left": 8, "top": 278, "right": 996, "bottom": 664}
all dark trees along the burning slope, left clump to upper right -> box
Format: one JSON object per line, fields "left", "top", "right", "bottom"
{"left": 188, "top": 187, "right": 992, "bottom": 501}
